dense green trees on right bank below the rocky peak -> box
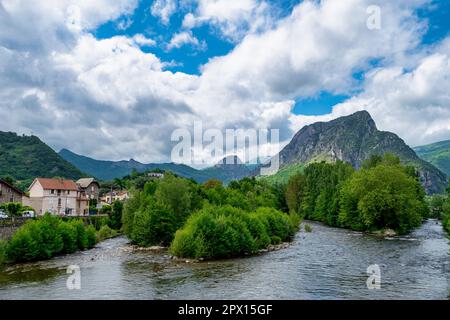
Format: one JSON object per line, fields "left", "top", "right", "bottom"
{"left": 286, "top": 154, "right": 428, "bottom": 233}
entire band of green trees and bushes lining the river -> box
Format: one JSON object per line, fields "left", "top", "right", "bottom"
{"left": 0, "top": 154, "right": 450, "bottom": 262}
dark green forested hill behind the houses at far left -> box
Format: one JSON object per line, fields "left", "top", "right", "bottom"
{"left": 0, "top": 131, "right": 83, "bottom": 180}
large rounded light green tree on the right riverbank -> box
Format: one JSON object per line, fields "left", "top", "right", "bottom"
{"left": 339, "top": 157, "right": 428, "bottom": 233}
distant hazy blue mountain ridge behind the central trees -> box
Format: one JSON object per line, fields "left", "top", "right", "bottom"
{"left": 59, "top": 149, "right": 250, "bottom": 183}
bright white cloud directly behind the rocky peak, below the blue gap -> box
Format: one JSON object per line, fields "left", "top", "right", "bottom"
{"left": 292, "top": 38, "right": 450, "bottom": 146}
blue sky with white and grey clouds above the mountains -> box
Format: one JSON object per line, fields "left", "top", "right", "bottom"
{"left": 0, "top": 0, "right": 450, "bottom": 162}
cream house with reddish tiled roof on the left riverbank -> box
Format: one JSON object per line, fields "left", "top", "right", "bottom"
{"left": 24, "top": 178, "right": 89, "bottom": 216}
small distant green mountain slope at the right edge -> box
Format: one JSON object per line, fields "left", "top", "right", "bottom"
{"left": 414, "top": 140, "right": 450, "bottom": 177}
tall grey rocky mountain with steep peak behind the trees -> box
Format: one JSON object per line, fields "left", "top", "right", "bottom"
{"left": 264, "top": 111, "right": 447, "bottom": 194}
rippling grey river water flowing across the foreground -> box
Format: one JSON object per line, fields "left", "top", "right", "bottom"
{"left": 0, "top": 220, "right": 450, "bottom": 299}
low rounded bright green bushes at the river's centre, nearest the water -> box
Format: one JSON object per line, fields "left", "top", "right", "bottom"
{"left": 170, "top": 206, "right": 295, "bottom": 259}
